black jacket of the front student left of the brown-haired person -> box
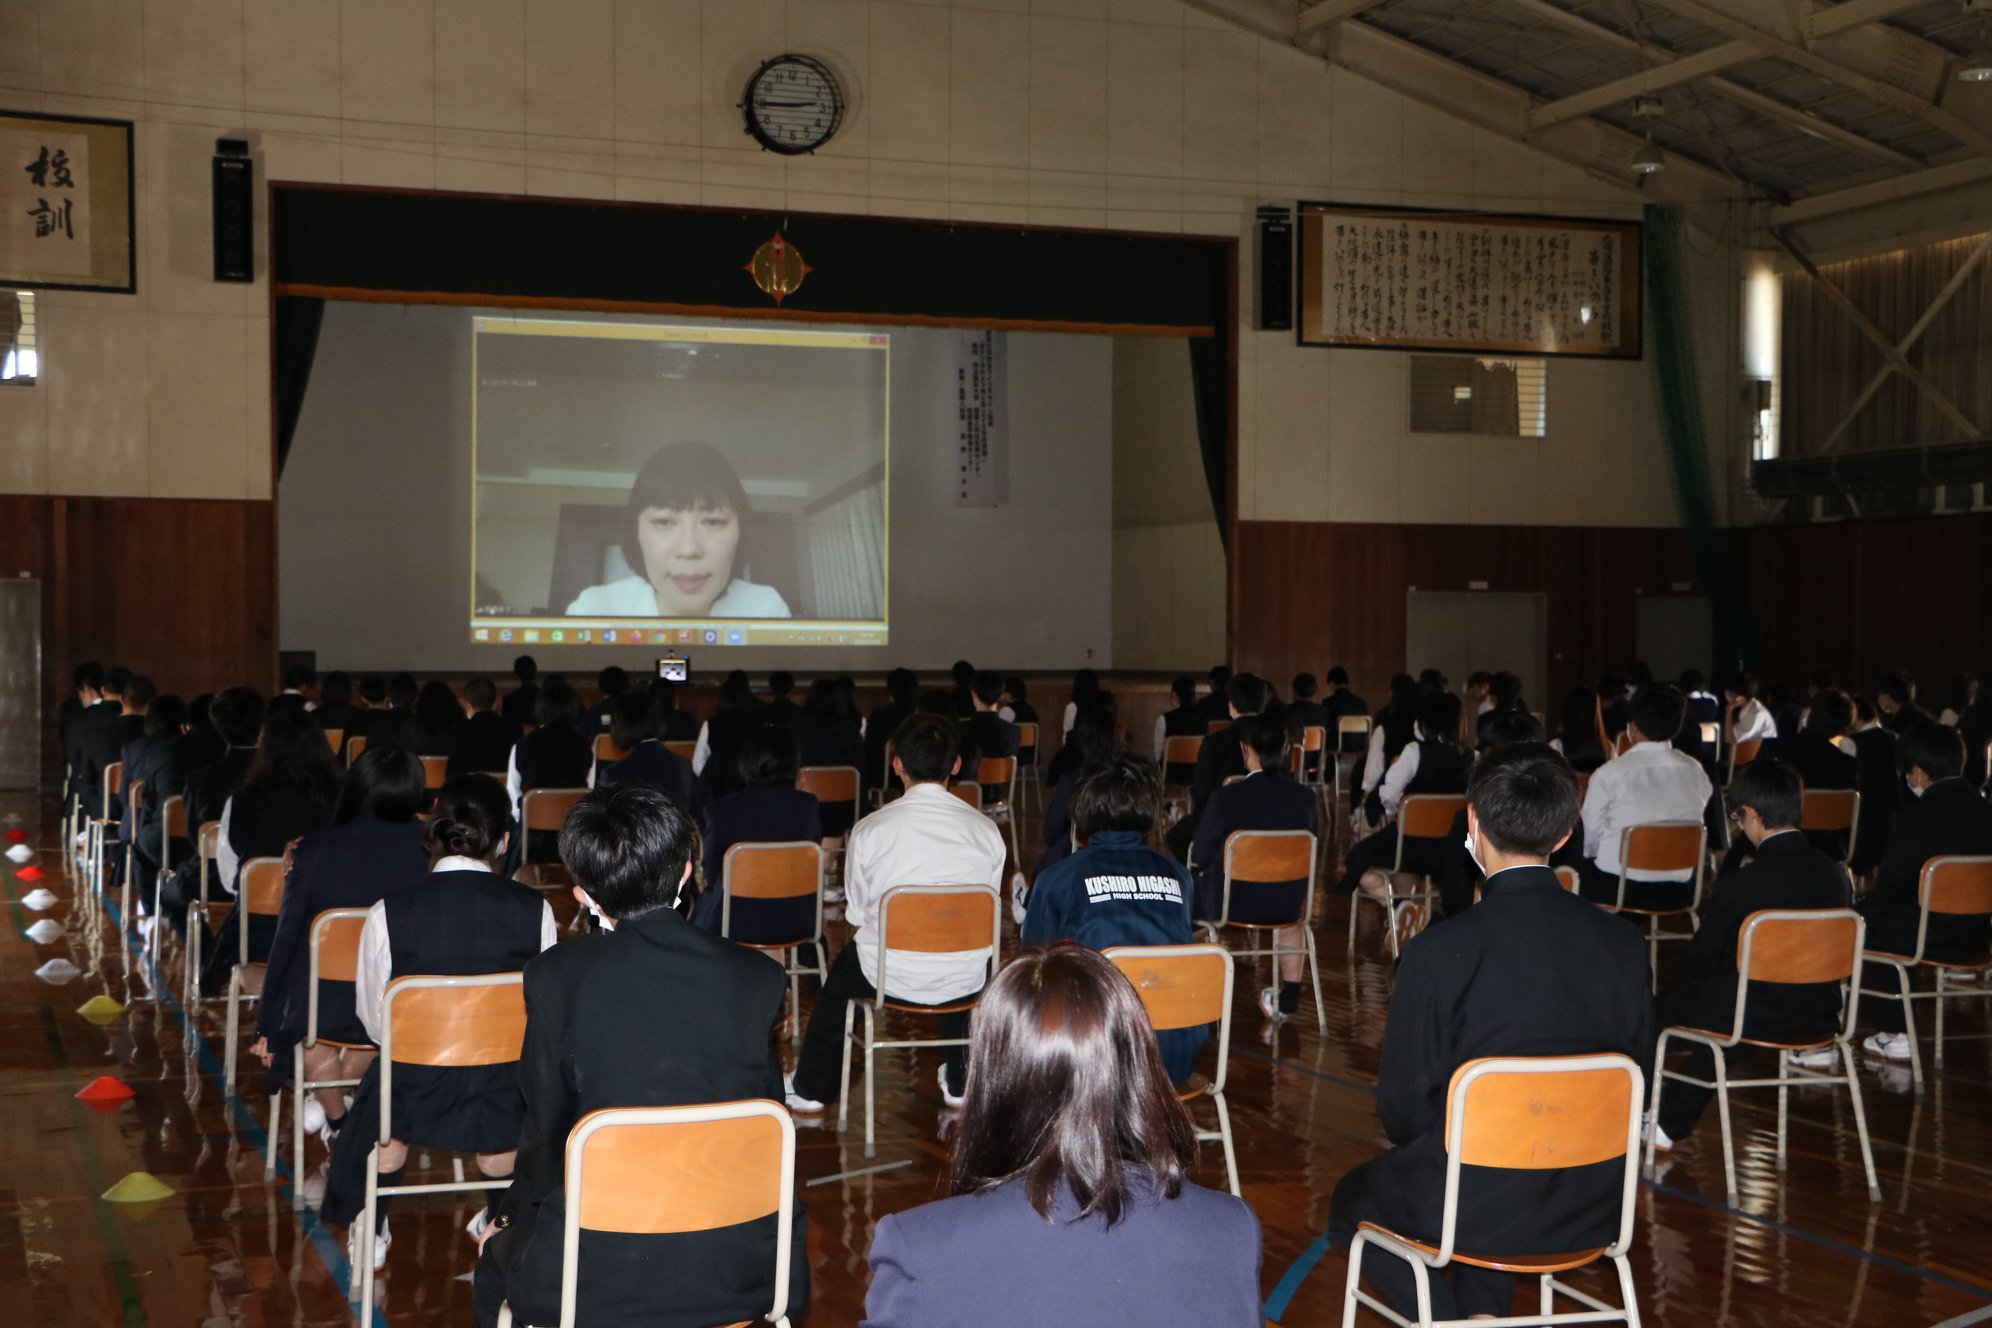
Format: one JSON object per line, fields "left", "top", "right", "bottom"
{"left": 478, "top": 910, "right": 809, "bottom": 1328}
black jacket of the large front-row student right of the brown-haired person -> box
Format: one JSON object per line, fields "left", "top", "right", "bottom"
{"left": 1370, "top": 866, "right": 1653, "bottom": 1252}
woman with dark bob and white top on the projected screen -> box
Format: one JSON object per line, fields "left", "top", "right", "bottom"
{"left": 568, "top": 442, "right": 789, "bottom": 617}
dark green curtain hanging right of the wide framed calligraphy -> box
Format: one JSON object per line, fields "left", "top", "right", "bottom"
{"left": 1645, "top": 203, "right": 1757, "bottom": 669}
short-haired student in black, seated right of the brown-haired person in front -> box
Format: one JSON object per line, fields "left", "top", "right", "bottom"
{"left": 1329, "top": 748, "right": 1649, "bottom": 1320}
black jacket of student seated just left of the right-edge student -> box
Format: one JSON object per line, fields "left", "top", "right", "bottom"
{"left": 1661, "top": 834, "right": 1849, "bottom": 1039}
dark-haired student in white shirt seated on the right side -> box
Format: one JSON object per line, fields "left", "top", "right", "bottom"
{"left": 1578, "top": 683, "right": 1713, "bottom": 908}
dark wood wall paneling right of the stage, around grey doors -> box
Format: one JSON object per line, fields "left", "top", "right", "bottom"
{"left": 1231, "top": 522, "right": 1705, "bottom": 711}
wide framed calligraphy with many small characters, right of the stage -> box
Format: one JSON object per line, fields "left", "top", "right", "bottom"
{"left": 1299, "top": 203, "right": 1639, "bottom": 360}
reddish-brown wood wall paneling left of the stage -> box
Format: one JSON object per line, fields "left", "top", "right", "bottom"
{"left": 0, "top": 494, "right": 277, "bottom": 778}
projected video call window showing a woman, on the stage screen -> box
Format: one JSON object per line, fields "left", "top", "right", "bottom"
{"left": 470, "top": 315, "right": 892, "bottom": 645}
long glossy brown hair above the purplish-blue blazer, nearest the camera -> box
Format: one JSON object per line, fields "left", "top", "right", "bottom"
{"left": 950, "top": 944, "right": 1197, "bottom": 1226}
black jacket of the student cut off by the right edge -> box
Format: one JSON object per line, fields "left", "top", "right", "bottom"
{"left": 1861, "top": 778, "right": 1992, "bottom": 960}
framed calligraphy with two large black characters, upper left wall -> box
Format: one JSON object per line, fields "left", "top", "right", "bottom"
{"left": 0, "top": 111, "right": 137, "bottom": 293}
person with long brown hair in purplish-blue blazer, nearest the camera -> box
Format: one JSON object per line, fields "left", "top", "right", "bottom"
{"left": 865, "top": 946, "right": 1265, "bottom": 1328}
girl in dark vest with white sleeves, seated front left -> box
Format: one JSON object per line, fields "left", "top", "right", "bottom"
{"left": 321, "top": 775, "right": 553, "bottom": 1268}
